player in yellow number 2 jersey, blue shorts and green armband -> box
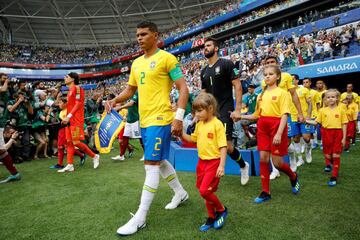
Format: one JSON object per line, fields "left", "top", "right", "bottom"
{"left": 106, "top": 22, "right": 189, "bottom": 235}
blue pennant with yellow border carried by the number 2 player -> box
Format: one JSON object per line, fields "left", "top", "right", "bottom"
{"left": 95, "top": 109, "right": 123, "bottom": 153}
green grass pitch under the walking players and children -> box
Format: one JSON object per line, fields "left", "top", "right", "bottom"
{"left": 0, "top": 141, "right": 360, "bottom": 240}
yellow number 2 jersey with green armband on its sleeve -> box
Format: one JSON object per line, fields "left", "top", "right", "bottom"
{"left": 128, "top": 49, "right": 183, "bottom": 128}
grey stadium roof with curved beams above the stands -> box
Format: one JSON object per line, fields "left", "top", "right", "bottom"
{"left": 0, "top": 0, "right": 225, "bottom": 48}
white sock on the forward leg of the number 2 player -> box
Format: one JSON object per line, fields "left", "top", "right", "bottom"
{"left": 135, "top": 165, "right": 160, "bottom": 221}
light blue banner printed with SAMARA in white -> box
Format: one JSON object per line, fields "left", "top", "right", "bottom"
{"left": 289, "top": 56, "right": 360, "bottom": 78}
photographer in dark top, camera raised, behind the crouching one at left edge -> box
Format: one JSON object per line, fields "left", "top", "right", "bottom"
{"left": 7, "top": 92, "right": 34, "bottom": 161}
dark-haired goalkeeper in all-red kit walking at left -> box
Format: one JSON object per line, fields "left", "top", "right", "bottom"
{"left": 58, "top": 72, "right": 100, "bottom": 173}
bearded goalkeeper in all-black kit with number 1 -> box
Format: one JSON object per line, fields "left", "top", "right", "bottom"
{"left": 200, "top": 38, "right": 249, "bottom": 185}
